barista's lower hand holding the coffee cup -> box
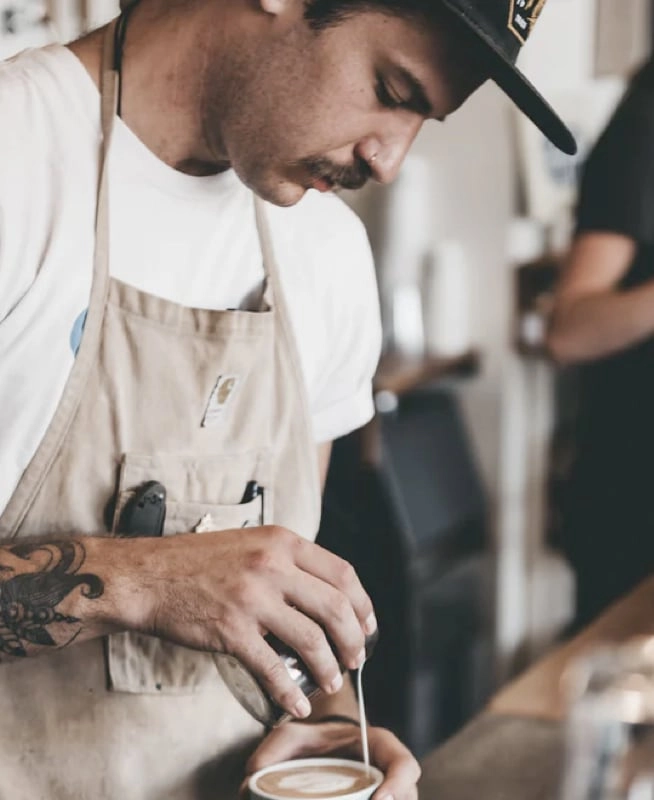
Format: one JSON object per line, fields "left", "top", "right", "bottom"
{"left": 241, "top": 722, "right": 420, "bottom": 800}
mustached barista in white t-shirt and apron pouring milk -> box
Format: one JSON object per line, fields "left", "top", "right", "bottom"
{"left": 0, "top": 0, "right": 574, "bottom": 800}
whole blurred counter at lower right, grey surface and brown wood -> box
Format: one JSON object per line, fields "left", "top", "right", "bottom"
{"left": 419, "top": 577, "right": 654, "bottom": 800}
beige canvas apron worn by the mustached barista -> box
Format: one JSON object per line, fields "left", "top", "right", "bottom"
{"left": 0, "top": 24, "right": 320, "bottom": 800}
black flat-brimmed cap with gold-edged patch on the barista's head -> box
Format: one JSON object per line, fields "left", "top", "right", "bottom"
{"left": 441, "top": 0, "right": 577, "bottom": 155}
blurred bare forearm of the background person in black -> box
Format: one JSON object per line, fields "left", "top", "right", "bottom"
{"left": 548, "top": 282, "right": 654, "bottom": 363}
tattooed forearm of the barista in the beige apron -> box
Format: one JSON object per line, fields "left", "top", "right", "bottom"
{"left": 0, "top": 536, "right": 148, "bottom": 660}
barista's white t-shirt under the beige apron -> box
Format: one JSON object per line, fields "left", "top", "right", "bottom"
{"left": 0, "top": 45, "right": 381, "bottom": 511}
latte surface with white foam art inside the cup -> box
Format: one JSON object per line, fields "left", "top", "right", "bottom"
{"left": 256, "top": 764, "right": 375, "bottom": 800}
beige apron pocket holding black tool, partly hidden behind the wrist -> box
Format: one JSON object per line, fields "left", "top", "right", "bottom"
{"left": 106, "top": 452, "right": 272, "bottom": 694}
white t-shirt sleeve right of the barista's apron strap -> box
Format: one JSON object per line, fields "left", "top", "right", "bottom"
{"left": 309, "top": 198, "right": 382, "bottom": 442}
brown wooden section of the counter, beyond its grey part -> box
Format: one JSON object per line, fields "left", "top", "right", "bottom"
{"left": 489, "top": 577, "right": 654, "bottom": 720}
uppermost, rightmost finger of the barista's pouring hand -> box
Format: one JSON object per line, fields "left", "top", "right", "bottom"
{"left": 295, "top": 539, "right": 377, "bottom": 636}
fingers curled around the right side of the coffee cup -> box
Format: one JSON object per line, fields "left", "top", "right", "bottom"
{"left": 368, "top": 728, "right": 420, "bottom": 800}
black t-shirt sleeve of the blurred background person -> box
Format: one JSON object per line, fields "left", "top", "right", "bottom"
{"left": 577, "top": 89, "right": 654, "bottom": 244}
